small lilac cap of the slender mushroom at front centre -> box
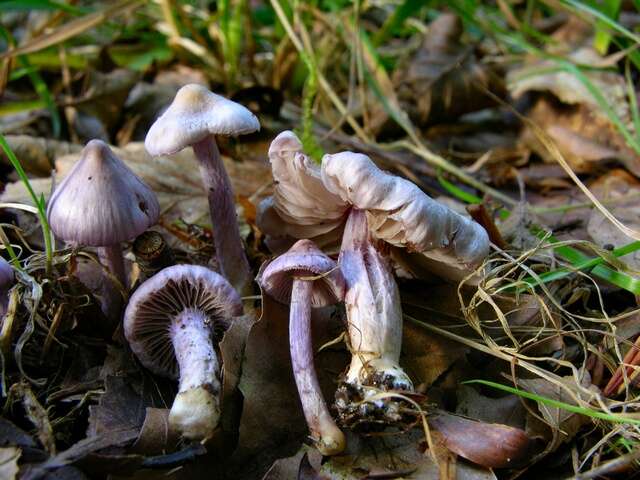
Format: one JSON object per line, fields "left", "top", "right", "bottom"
{"left": 258, "top": 240, "right": 346, "bottom": 307}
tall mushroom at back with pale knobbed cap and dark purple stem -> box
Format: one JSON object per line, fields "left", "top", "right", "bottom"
{"left": 145, "top": 84, "right": 260, "bottom": 292}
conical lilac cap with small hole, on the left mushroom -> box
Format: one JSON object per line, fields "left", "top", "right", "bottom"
{"left": 47, "top": 140, "right": 160, "bottom": 247}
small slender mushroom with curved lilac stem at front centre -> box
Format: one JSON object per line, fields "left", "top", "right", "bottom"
{"left": 258, "top": 240, "right": 346, "bottom": 455}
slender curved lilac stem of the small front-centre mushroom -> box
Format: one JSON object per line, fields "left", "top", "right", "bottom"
{"left": 289, "top": 278, "right": 346, "bottom": 455}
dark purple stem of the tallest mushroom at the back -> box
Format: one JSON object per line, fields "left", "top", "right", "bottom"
{"left": 193, "top": 135, "right": 251, "bottom": 294}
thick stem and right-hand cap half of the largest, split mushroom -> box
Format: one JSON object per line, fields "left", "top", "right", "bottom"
{"left": 322, "top": 152, "right": 489, "bottom": 417}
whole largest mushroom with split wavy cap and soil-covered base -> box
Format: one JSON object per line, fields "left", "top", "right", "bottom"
{"left": 258, "top": 132, "right": 489, "bottom": 418}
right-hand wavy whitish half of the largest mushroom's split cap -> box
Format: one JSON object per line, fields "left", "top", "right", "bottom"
{"left": 322, "top": 152, "right": 489, "bottom": 267}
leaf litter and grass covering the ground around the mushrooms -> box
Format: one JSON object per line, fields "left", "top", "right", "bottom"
{"left": 0, "top": 0, "right": 640, "bottom": 480}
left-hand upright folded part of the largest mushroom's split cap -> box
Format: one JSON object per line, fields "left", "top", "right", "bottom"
{"left": 258, "top": 131, "right": 349, "bottom": 246}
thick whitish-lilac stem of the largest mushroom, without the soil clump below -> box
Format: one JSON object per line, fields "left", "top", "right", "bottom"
{"left": 339, "top": 208, "right": 413, "bottom": 390}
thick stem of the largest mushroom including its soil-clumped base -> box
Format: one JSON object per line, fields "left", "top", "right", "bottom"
{"left": 336, "top": 208, "right": 413, "bottom": 423}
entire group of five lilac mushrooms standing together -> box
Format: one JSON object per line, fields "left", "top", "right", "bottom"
{"left": 41, "top": 85, "right": 489, "bottom": 455}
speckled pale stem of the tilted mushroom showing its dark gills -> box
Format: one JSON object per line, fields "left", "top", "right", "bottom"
{"left": 169, "top": 309, "right": 220, "bottom": 439}
